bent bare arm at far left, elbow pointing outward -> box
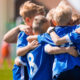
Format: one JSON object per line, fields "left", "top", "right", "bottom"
{"left": 3, "top": 25, "right": 30, "bottom": 43}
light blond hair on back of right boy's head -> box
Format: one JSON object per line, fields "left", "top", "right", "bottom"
{"left": 53, "top": 2, "right": 72, "bottom": 26}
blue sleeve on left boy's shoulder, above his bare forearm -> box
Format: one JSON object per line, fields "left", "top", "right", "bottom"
{"left": 17, "top": 32, "right": 28, "bottom": 48}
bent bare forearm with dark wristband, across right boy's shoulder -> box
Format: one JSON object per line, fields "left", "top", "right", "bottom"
{"left": 47, "top": 28, "right": 68, "bottom": 45}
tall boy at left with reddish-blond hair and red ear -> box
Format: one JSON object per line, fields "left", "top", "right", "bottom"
{"left": 13, "top": 1, "right": 44, "bottom": 80}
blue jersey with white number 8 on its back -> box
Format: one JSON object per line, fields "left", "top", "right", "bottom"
{"left": 17, "top": 32, "right": 54, "bottom": 80}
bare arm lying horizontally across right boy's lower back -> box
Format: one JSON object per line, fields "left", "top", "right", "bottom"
{"left": 45, "top": 44, "right": 78, "bottom": 57}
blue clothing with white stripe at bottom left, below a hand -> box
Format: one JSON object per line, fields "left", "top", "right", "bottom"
{"left": 12, "top": 64, "right": 28, "bottom": 80}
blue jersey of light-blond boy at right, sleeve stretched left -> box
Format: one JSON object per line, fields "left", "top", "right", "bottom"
{"left": 38, "top": 25, "right": 80, "bottom": 76}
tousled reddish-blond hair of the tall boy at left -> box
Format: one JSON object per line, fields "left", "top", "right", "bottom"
{"left": 19, "top": 1, "right": 45, "bottom": 19}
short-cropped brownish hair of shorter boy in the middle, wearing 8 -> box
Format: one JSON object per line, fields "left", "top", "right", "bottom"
{"left": 32, "top": 15, "right": 49, "bottom": 34}
